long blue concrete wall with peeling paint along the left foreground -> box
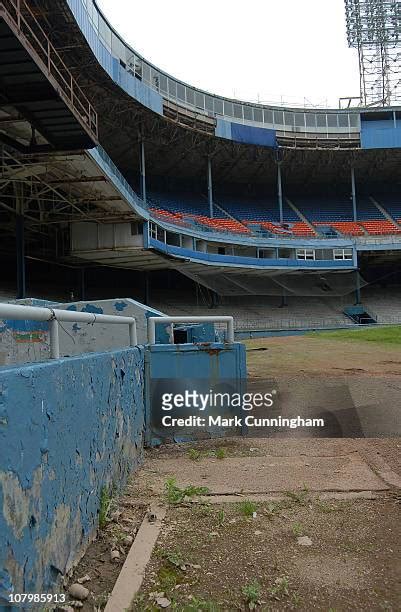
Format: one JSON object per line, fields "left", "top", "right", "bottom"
{"left": 0, "top": 347, "right": 144, "bottom": 607}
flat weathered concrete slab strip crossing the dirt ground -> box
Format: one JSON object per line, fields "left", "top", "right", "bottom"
{"left": 145, "top": 453, "right": 389, "bottom": 495}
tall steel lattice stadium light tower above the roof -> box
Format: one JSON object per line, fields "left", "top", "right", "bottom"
{"left": 345, "top": 0, "right": 401, "bottom": 106}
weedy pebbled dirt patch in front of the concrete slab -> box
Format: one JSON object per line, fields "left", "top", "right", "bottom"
{"left": 132, "top": 496, "right": 401, "bottom": 612}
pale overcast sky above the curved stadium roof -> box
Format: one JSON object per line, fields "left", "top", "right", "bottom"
{"left": 98, "top": 0, "right": 359, "bottom": 107}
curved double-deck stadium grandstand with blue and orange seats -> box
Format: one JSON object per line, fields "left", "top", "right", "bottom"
{"left": 0, "top": 0, "right": 401, "bottom": 331}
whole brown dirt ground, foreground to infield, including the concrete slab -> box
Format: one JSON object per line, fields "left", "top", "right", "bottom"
{"left": 61, "top": 336, "right": 401, "bottom": 612}
